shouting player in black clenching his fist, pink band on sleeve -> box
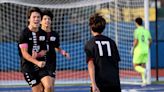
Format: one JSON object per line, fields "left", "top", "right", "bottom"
{"left": 19, "top": 7, "right": 52, "bottom": 92}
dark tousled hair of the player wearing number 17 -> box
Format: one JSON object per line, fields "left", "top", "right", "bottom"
{"left": 89, "top": 13, "right": 106, "bottom": 33}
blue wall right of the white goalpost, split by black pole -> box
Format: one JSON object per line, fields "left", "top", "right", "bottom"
{"left": 150, "top": 20, "right": 164, "bottom": 68}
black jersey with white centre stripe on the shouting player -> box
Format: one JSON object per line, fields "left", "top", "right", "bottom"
{"left": 19, "top": 28, "right": 46, "bottom": 72}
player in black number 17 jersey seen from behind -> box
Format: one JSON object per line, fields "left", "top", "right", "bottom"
{"left": 85, "top": 14, "right": 121, "bottom": 92}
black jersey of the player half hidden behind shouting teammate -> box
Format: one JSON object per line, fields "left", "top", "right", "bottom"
{"left": 46, "top": 31, "right": 60, "bottom": 72}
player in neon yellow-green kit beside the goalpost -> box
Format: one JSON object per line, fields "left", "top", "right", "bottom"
{"left": 133, "top": 17, "right": 152, "bottom": 86}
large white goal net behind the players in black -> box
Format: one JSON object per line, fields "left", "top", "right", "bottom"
{"left": 0, "top": 0, "right": 151, "bottom": 85}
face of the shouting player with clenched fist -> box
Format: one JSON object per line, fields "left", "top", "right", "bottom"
{"left": 29, "top": 12, "right": 41, "bottom": 28}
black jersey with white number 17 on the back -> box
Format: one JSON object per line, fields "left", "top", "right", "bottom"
{"left": 85, "top": 35, "right": 120, "bottom": 86}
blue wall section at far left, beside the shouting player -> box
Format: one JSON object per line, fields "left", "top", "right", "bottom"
{"left": 0, "top": 42, "right": 20, "bottom": 70}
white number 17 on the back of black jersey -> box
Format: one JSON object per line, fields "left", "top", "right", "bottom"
{"left": 95, "top": 41, "right": 111, "bottom": 56}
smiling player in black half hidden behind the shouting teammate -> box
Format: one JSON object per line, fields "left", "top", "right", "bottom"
{"left": 41, "top": 10, "right": 70, "bottom": 91}
